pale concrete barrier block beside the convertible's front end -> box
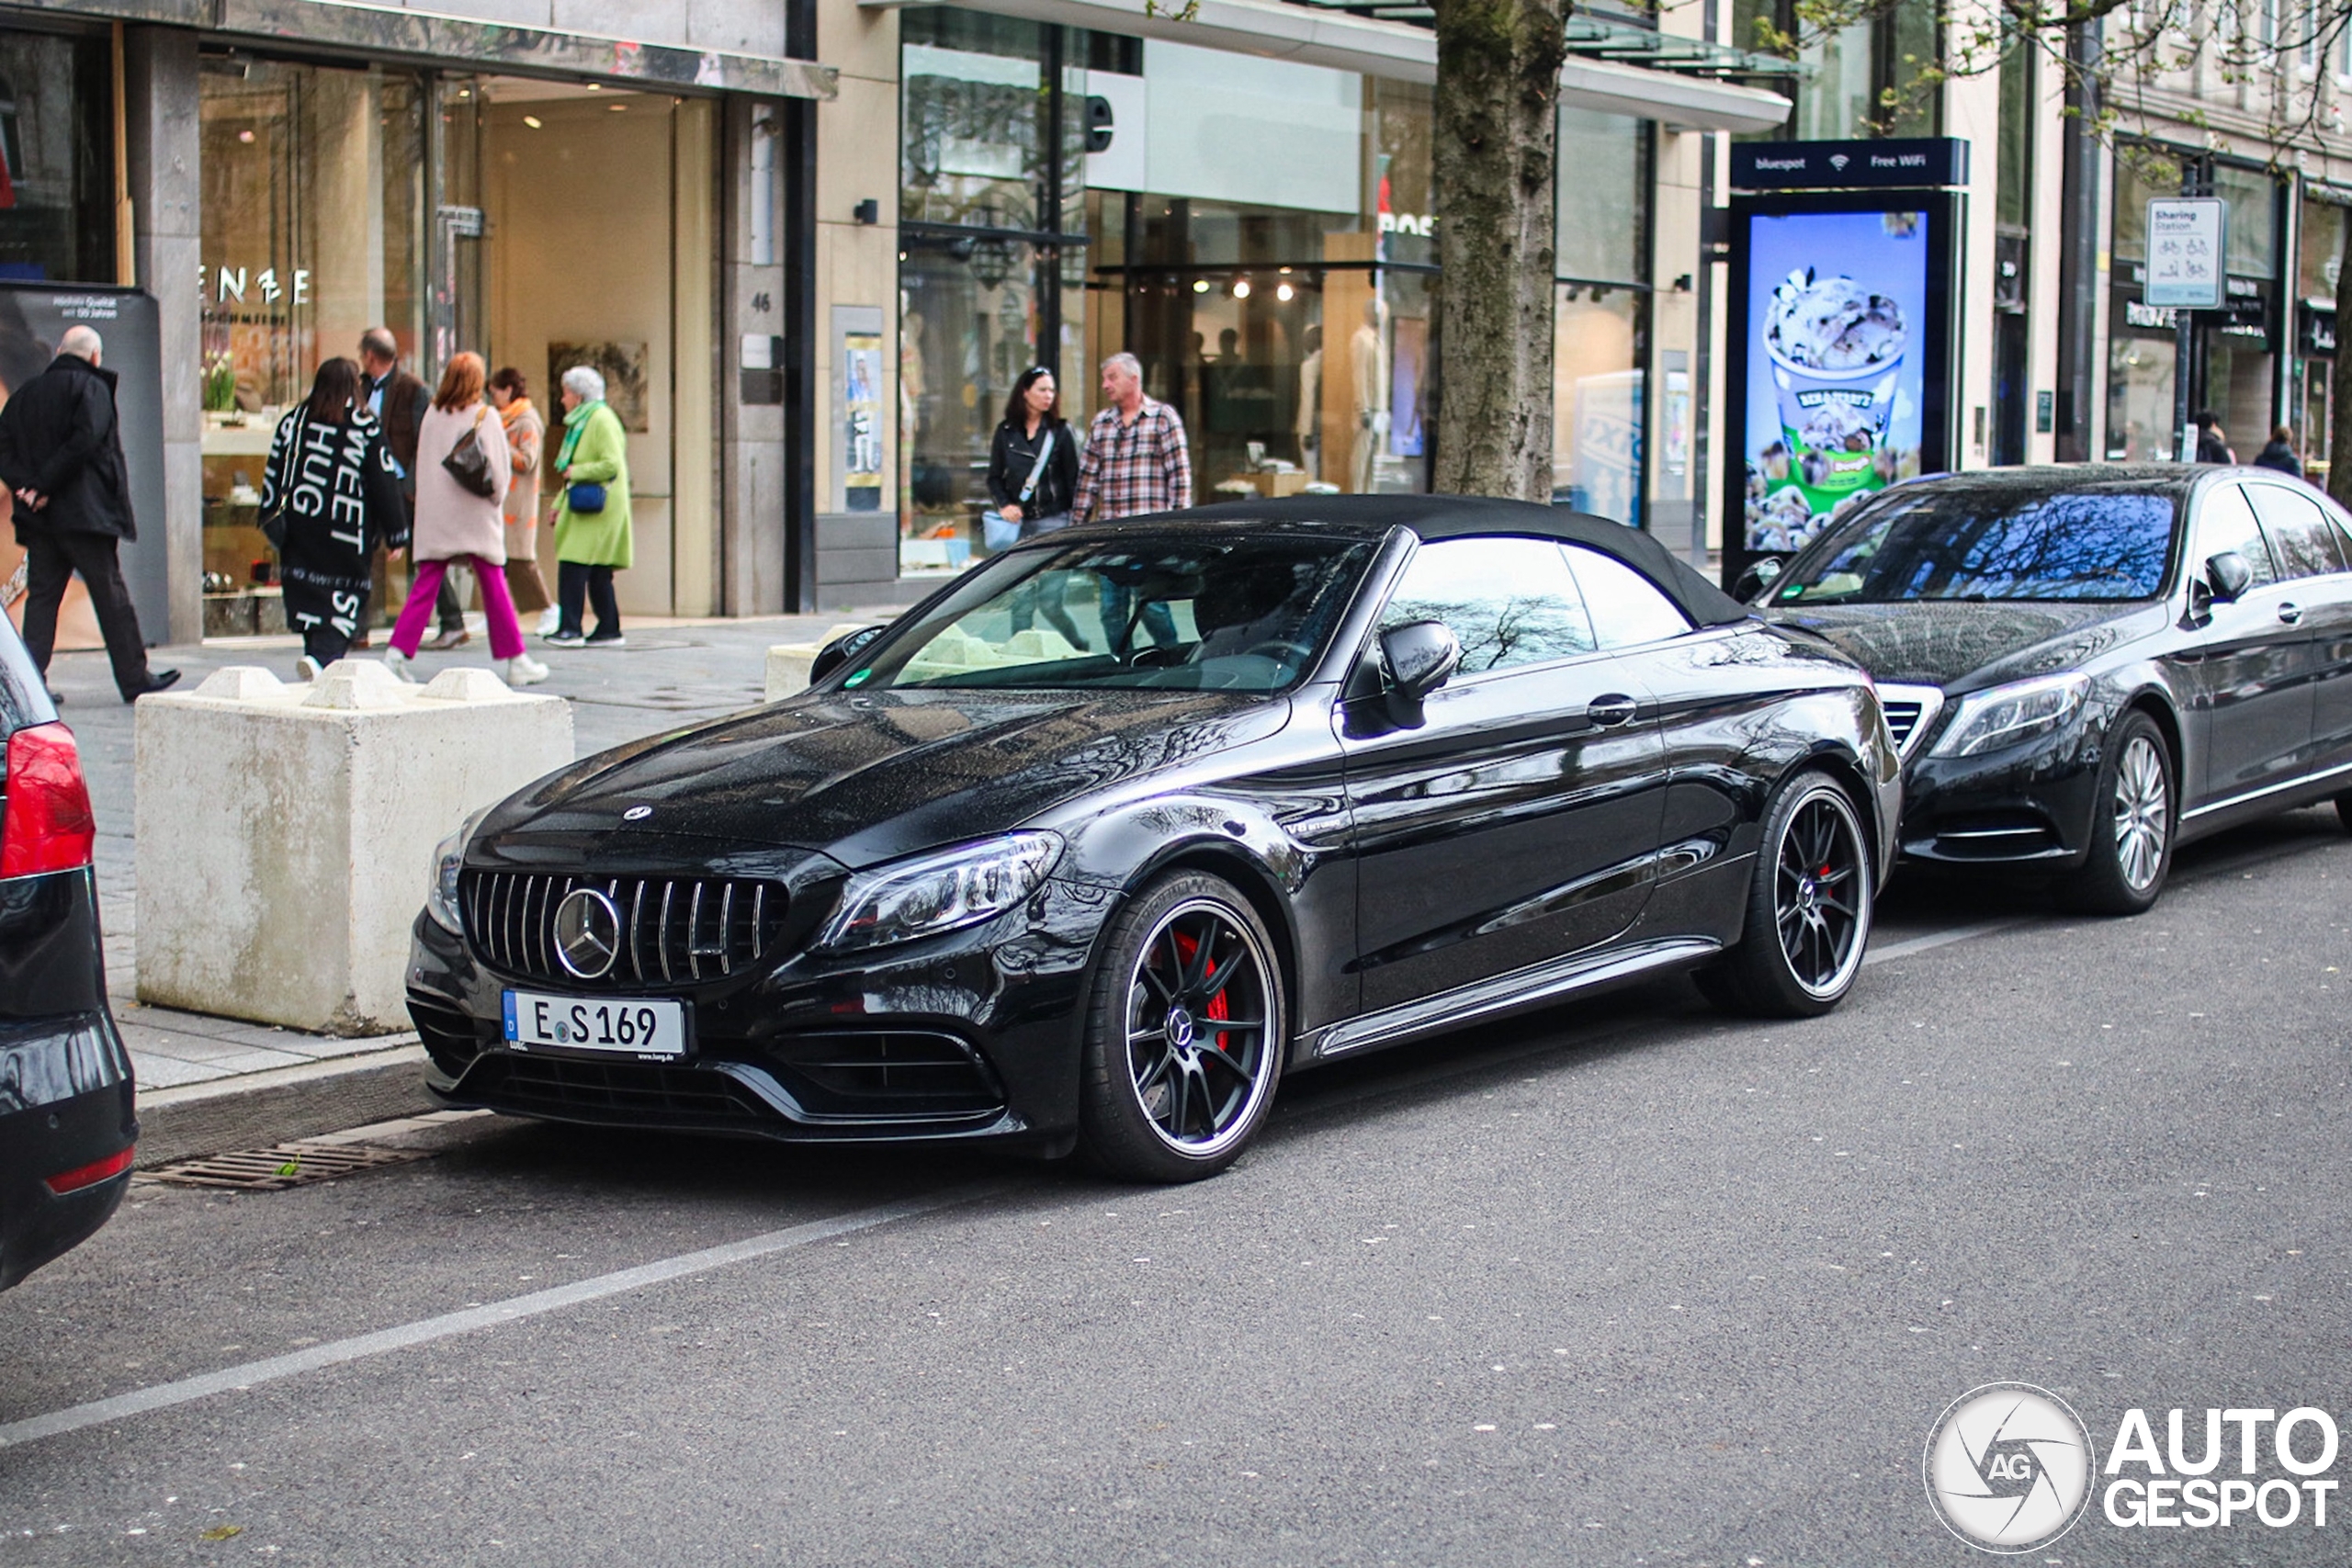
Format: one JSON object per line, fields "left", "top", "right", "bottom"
{"left": 134, "top": 660, "right": 571, "bottom": 1034}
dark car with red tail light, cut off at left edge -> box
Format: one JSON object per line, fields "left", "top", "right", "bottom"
{"left": 0, "top": 618, "right": 139, "bottom": 1291}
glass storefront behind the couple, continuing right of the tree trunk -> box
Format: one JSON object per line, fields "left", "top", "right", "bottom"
{"left": 899, "top": 7, "right": 1654, "bottom": 576}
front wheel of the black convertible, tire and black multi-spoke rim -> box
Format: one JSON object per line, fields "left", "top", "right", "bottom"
{"left": 1080, "top": 872, "right": 1289, "bottom": 1182}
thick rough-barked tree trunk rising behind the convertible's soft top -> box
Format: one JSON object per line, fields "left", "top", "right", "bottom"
{"left": 1432, "top": 0, "right": 1566, "bottom": 501}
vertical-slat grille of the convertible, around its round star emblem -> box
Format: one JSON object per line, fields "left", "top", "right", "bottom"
{"left": 458, "top": 872, "right": 788, "bottom": 987}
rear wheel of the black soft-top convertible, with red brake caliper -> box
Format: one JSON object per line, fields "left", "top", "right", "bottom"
{"left": 1698, "top": 769, "right": 1874, "bottom": 1018}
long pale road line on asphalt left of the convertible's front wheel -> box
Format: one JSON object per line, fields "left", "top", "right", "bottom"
{"left": 0, "top": 1182, "right": 1013, "bottom": 1448}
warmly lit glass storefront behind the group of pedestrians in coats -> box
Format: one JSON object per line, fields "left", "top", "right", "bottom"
{"left": 200, "top": 54, "right": 715, "bottom": 630}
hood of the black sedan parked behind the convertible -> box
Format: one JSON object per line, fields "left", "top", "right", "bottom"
{"left": 1769, "top": 600, "right": 2164, "bottom": 691}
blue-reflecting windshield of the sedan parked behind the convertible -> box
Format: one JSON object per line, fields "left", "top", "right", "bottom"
{"left": 1771, "top": 484, "right": 2178, "bottom": 604}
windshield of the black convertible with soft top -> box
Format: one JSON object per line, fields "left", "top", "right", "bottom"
{"left": 842, "top": 536, "right": 1374, "bottom": 694}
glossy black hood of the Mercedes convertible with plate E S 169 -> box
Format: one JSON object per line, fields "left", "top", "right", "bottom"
{"left": 484, "top": 691, "right": 1291, "bottom": 867}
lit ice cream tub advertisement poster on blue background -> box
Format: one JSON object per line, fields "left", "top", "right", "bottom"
{"left": 1743, "top": 211, "right": 1931, "bottom": 552}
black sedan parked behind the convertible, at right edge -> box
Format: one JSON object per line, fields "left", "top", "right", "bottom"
{"left": 1752, "top": 466, "right": 2352, "bottom": 915}
